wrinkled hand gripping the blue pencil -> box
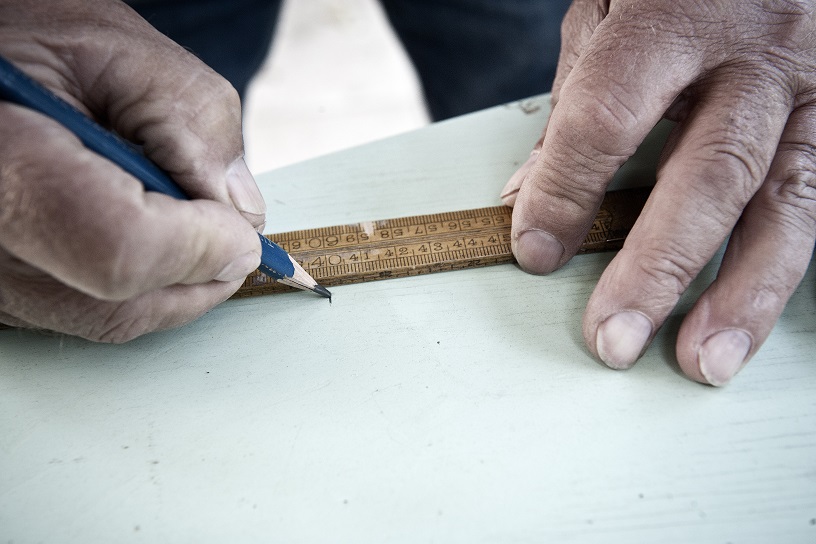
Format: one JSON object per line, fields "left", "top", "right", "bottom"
{"left": 0, "top": 0, "right": 265, "bottom": 342}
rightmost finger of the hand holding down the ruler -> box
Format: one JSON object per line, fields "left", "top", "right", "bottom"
{"left": 677, "top": 105, "right": 816, "bottom": 385}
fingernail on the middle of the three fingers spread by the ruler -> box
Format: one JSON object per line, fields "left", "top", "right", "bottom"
{"left": 595, "top": 311, "right": 653, "bottom": 370}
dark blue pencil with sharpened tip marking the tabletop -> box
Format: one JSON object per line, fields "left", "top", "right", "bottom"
{"left": 0, "top": 56, "right": 331, "bottom": 299}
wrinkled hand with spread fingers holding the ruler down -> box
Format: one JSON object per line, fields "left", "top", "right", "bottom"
{"left": 502, "top": 0, "right": 816, "bottom": 385}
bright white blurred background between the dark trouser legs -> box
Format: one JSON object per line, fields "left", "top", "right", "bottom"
{"left": 244, "top": 0, "right": 428, "bottom": 174}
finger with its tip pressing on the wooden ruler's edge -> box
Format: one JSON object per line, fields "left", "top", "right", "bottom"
{"left": 511, "top": 3, "right": 701, "bottom": 273}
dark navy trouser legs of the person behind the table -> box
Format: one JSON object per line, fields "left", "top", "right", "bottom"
{"left": 129, "top": 0, "right": 570, "bottom": 120}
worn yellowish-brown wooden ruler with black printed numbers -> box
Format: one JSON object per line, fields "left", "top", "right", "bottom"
{"left": 233, "top": 187, "right": 651, "bottom": 298}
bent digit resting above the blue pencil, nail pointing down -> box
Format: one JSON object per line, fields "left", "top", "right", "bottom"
{"left": 96, "top": 27, "right": 266, "bottom": 230}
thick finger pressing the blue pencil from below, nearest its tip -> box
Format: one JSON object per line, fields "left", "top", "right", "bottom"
{"left": 0, "top": 104, "right": 261, "bottom": 300}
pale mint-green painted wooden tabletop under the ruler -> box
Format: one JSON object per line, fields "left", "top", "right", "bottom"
{"left": 0, "top": 97, "right": 816, "bottom": 544}
